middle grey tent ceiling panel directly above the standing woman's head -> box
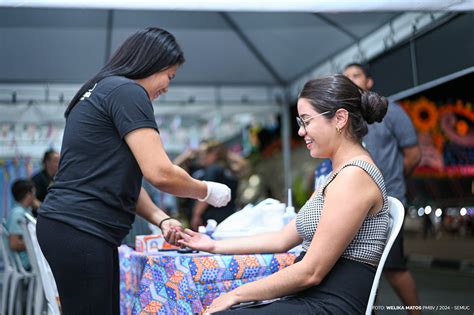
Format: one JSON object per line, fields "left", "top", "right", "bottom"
{"left": 112, "top": 11, "right": 277, "bottom": 84}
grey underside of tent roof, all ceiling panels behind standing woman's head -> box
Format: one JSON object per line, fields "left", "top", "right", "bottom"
{"left": 0, "top": 8, "right": 399, "bottom": 85}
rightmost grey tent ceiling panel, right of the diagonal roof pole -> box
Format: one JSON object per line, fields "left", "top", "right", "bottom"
{"left": 229, "top": 12, "right": 352, "bottom": 82}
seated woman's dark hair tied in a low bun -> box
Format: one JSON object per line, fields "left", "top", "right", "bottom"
{"left": 299, "top": 74, "right": 388, "bottom": 140}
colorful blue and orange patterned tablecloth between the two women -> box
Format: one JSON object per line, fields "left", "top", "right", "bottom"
{"left": 119, "top": 246, "right": 296, "bottom": 315}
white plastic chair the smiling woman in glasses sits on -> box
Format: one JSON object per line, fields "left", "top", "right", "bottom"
{"left": 365, "top": 197, "right": 405, "bottom": 315}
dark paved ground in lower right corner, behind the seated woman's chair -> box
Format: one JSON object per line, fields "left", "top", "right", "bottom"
{"left": 376, "top": 232, "right": 474, "bottom": 315}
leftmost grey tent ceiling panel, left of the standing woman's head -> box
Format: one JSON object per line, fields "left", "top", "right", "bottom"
{"left": 0, "top": 8, "right": 106, "bottom": 82}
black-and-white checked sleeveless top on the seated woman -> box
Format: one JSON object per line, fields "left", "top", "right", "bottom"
{"left": 296, "top": 160, "right": 388, "bottom": 266}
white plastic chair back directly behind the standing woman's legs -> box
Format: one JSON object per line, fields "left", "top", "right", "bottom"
{"left": 23, "top": 214, "right": 61, "bottom": 315}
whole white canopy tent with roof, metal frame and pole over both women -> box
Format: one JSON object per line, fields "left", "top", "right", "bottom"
{"left": 0, "top": 0, "right": 474, "bottom": 193}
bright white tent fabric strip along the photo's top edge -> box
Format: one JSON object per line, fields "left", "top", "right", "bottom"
{"left": 2, "top": 0, "right": 474, "bottom": 12}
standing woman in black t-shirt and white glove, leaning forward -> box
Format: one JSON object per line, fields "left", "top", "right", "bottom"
{"left": 36, "top": 27, "right": 231, "bottom": 315}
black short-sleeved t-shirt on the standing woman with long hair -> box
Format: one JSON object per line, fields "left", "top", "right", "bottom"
{"left": 38, "top": 76, "right": 158, "bottom": 245}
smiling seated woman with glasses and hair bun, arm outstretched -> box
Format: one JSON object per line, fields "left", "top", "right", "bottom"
{"left": 180, "top": 75, "right": 388, "bottom": 314}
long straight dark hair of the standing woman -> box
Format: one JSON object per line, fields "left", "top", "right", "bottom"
{"left": 64, "top": 27, "right": 185, "bottom": 118}
